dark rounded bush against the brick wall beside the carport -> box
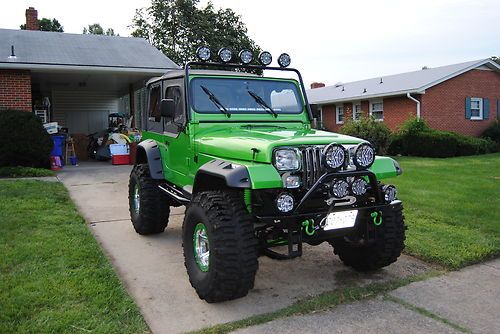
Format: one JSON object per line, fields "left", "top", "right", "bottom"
{"left": 0, "top": 110, "right": 53, "bottom": 167}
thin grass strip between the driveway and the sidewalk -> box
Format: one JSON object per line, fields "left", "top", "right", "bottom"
{"left": 190, "top": 270, "right": 442, "bottom": 334}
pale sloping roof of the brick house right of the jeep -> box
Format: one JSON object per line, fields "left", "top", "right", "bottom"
{"left": 306, "top": 59, "right": 500, "bottom": 104}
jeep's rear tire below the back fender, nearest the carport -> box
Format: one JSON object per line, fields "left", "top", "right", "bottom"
{"left": 128, "top": 164, "right": 170, "bottom": 235}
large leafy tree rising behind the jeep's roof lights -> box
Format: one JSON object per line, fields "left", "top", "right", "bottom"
{"left": 132, "top": 0, "right": 261, "bottom": 64}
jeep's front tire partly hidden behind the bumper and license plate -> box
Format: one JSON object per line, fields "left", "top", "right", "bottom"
{"left": 330, "top": 205, "right": 405, "bottom": 271}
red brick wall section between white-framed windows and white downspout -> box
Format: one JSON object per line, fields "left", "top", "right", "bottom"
{"left": 384, "top": 95, "right": 420, "bottom": 131}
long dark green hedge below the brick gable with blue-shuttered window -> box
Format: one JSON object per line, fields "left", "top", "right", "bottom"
{"left": 389, "top": 119, "right": 496, "bottom": 158}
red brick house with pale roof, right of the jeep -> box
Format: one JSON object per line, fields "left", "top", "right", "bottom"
{"left": 307, "top": 59, "right": 500, "bottom": 136}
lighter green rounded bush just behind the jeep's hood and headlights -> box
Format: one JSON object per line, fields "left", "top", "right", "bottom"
{"left": 341, "top": 117, "right": 391, "bottom": 155}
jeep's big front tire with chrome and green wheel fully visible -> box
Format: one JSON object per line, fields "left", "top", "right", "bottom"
{"left": 182, "top": 191, "right": 258, "bottom": 303}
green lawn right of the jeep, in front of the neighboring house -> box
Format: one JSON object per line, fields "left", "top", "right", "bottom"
{"left": 391, "top": 153, "right": 500, "bottom": 269}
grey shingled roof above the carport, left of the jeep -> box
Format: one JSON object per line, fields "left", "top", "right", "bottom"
{"left": 0, "top": 29, "right": 179, "bottom": 72}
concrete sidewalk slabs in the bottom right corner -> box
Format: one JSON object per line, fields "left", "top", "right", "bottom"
{"left": 236, "top": 259, "right": 500, "bottom": 334}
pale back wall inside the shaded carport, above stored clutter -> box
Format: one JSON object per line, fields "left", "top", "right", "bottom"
{"left": 52, "top": 91, "right": 119, "bottom": 134}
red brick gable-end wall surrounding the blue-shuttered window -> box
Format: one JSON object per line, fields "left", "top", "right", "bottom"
{"left": 422, "top": 70, "right": 500, "bottom": 136}
